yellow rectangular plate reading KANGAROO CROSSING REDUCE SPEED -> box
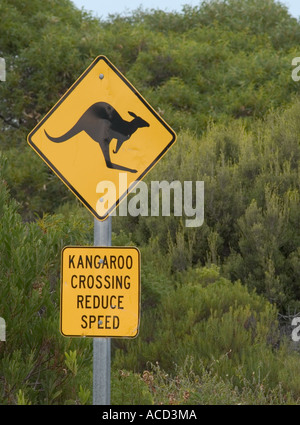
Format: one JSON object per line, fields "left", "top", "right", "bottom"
{"left": 60, "top": 246, "right": 140, "bottom": 338}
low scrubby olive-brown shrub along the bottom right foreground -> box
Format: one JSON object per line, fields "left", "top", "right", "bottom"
{"left": 142, "top": 357, "right": 298, "bottom": 405}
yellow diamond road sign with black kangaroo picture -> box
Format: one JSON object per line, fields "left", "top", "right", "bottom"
{"left": 28, "top": 56, "right": 176, "bottom": 220}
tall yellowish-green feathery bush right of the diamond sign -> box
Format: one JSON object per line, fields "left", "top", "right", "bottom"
{"left": 115, "top": 101, "right": 300, "bottom": 313}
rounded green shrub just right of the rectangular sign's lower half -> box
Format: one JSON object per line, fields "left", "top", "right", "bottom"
{"left": 114, "top": 267, "right": 299, "bottom": 403}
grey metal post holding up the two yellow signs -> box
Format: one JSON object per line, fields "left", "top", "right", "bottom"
{"left": 93, "top": 217, "right": 111, "bottom": 405}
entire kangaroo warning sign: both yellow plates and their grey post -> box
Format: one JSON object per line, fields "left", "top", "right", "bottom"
{"left": 27, "top": 56, "right": 176, "bottom": 405}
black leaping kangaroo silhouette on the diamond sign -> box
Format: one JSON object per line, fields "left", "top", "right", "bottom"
{"left": 44, "top": 102, "right": 149, "bottom": 173}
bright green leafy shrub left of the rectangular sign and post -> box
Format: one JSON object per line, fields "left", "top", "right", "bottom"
{"left": 0, "top": 176, "right": 91, "bottom": 404}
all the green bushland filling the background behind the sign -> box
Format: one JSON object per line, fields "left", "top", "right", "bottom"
{"left": 0, "top": 0, "right": 300, "bottom": 404}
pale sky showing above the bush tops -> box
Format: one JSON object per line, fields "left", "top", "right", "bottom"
{"left": 72, "top": 0, "right": 300, "bottom": 19}
